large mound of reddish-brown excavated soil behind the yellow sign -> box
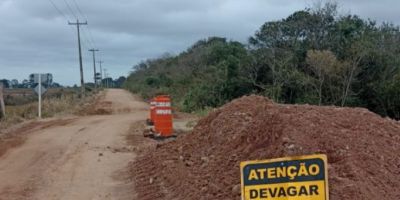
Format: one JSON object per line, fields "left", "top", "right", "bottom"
{"left": 131, "top": 96, "right": 400, "bottom": 200}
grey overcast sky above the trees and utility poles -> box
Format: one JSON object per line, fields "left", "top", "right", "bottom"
{"left": 0, "top": 0, "right": 400, "bottom": 85}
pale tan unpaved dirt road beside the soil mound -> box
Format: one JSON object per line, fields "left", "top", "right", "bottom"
{"left": 0, "top": 89, "right": 147, "bottom": 200}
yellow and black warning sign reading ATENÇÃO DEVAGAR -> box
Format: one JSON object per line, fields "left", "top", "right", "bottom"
{"left": 240, "top": 155, "right": 329, "bottom": 200}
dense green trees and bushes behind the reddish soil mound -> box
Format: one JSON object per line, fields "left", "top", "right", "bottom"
{"left": 125, "top": 3, "right": 400, "bottom": 119}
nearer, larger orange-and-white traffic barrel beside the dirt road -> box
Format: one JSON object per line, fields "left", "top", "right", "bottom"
{"left": 154, "top": 95, "right": 172, "bottom": 137}
